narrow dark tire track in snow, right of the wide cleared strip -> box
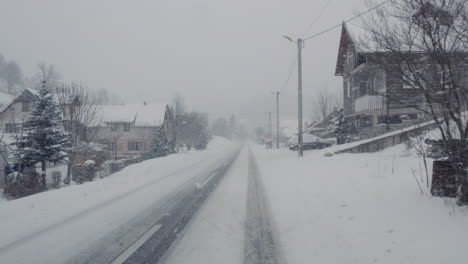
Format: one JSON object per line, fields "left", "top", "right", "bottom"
{"left": 244, "top": 149, "right": 286, "bottom": 264}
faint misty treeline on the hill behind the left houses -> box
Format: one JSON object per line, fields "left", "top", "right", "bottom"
{"left": 0, "top": 54, "right": 124, "bottom": 105}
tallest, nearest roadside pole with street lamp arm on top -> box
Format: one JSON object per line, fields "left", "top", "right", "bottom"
{"left": 283, "top": 36, "right": 304, "bottom": 157}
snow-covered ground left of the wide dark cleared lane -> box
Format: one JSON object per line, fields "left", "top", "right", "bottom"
{"left": 0, "top": 138, "right": 236, "bottom": 264}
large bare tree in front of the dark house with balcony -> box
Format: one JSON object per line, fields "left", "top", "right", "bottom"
{"left": 361, "top": 0, "right": 468, "bottom": 202}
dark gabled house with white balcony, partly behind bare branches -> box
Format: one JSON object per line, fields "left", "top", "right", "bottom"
{"left": 335, "top": 23, "right": 468, "bottom": 141}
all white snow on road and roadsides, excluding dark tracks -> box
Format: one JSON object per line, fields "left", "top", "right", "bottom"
{"left": 0, "top": 138, "right": 468, "bottom": 264}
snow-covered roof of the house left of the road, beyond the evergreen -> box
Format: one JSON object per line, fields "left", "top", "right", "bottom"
{"left": 98, "top": 104, "right": 166, "bottom": 126}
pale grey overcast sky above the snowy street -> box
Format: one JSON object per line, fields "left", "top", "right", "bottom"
{"left": 0, "top": 0, "right": 365, "bottom": 127}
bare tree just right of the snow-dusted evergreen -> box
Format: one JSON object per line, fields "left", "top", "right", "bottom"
{"left": 55, "top": 83, "right": 100, "bottom": 184}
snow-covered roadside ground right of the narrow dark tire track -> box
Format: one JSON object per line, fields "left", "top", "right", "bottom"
{"left": 252, "top": 145, "right": 468, "bottom": 264}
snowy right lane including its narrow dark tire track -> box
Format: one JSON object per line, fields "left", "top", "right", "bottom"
{"left": 166, "top": 148, "right": 284, "bottom": 264}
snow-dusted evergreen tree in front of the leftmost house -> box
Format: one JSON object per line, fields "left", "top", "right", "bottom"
{"left": 18, "top": 85, "right": 69, "bottom": 187}
